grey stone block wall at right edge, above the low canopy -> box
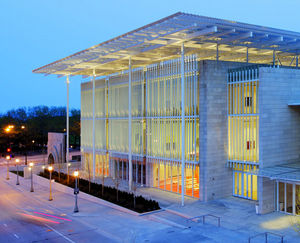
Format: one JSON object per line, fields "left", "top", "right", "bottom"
{"left": 259, "top": 67, "right": 300, "bottom": 168}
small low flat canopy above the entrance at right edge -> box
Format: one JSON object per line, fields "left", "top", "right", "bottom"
{"left": 258, "top": 162, "right": 300, "bottom": 182}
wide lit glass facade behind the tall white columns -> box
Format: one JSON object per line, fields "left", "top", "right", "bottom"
{"left": 81, "top": 55, "right": 199, "bottom": 197}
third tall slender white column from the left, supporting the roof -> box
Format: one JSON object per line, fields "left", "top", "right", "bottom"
{"left": 128, "top": 57, "right": 132, "bottom": 191}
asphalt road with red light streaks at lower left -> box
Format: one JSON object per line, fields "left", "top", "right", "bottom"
{"left": 0, "top": 172, "right": 113, "bottom": 243}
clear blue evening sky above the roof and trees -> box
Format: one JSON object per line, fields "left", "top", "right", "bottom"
{"left": 0, "top": 0, "right": 300, "bottom": 113}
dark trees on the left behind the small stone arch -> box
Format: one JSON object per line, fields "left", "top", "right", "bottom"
{"left": 0, "top": 106, "right": 80, "bottom": 154}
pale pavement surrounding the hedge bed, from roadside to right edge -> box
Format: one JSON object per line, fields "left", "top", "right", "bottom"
{"left": 6, "top": 170, "right": 300, "bottom": 243}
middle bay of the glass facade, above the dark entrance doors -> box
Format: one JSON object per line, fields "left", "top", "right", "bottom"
{"left": 108, "top": 68, "right": 146, "bottom": 184}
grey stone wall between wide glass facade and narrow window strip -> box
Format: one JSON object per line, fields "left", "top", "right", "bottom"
{"left": 199, "top": 61, "right": 249, "bottom": 201}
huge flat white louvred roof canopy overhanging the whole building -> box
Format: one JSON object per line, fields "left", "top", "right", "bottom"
{"left": 33, "top": 12, "right": 300, "bottom": 76}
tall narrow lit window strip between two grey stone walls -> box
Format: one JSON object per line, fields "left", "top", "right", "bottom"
{"left": 228, "top": 67, "right": 259, "bottom": 200}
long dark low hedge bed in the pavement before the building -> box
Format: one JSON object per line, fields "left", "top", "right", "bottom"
{"left": 40, "top": 170, "right": 160, "bottom": 213}
